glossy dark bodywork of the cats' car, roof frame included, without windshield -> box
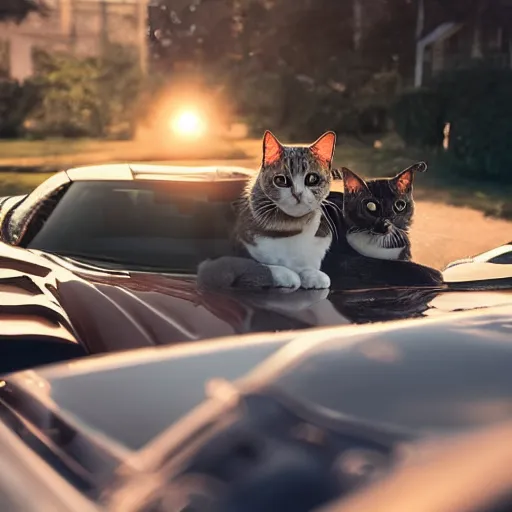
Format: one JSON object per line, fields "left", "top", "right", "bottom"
{"left": 0, "top": 165, "right": 512, "bottom": 373}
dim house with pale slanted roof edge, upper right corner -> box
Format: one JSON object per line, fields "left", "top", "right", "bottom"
{"left": 414, "top": 0, "right": 512, "bottom": 87}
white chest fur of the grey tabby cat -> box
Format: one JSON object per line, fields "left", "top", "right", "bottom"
{"left": 245, "top": 212, "right": 332, "bottom": 272}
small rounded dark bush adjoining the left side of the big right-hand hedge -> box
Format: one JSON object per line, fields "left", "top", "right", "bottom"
{"left": 392, "top": 89, "right": 444, "bottom": 148}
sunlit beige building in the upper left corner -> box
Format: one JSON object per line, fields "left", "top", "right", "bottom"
{"left": 0, "top": 0, "right": 147, "bottom": 81}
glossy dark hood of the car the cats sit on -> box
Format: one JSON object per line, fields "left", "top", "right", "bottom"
{"left": 0, "top": 242, "right": 512, "bottom": 353}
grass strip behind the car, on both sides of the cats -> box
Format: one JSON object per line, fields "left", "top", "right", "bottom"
{"left": 0, "top": 135, "right": 512, "bottom": 219}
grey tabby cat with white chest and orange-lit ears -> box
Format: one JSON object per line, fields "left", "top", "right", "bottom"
{"left": 198, "top": 131, "right": 336, "bottom": 289}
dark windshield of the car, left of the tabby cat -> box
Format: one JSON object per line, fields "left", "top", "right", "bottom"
{"left": 29, "top": 181, "right": 236, "bottom": 273}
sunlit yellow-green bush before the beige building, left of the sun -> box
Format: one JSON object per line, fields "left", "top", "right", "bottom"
{"left": 31, "top": 46, "right": 141, "bottom": 137}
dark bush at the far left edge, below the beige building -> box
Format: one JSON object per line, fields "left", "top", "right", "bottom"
{"left": 0, "top": 80, "right": 39, "bottom": 138}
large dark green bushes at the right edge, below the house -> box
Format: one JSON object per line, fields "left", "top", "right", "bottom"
{"left": 393, "top": 66, "right": 512, "bottom": 183}
